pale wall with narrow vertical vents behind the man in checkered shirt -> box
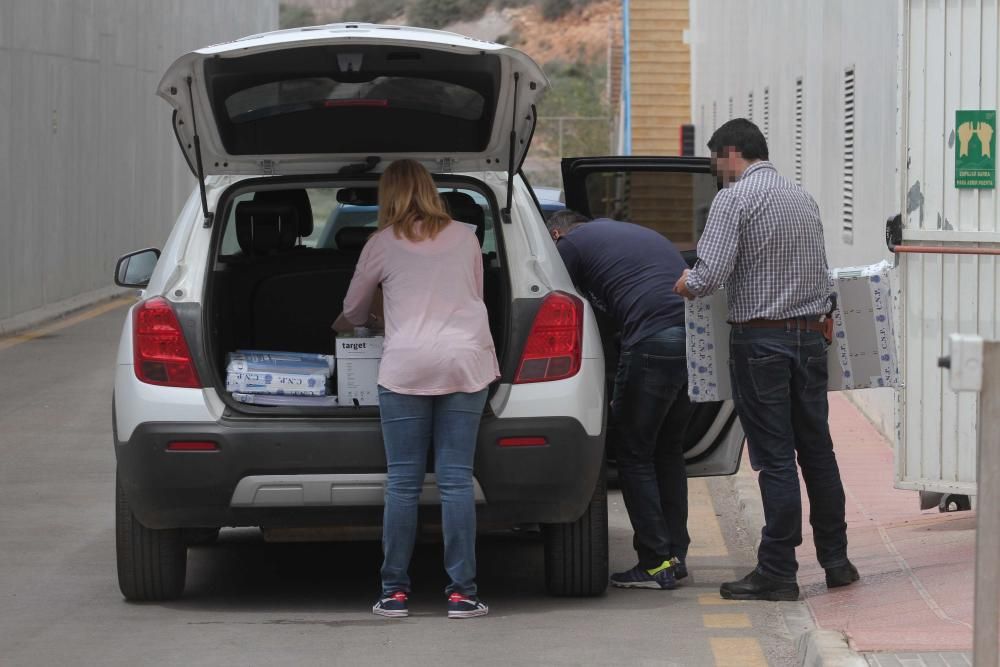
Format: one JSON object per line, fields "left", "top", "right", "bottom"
{"left": 690, "top": 0, "right": 900, "bottom": 436}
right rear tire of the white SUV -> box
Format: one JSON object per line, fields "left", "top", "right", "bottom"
{"left": 543, "top": 471, "right": 608, "bottom": 597}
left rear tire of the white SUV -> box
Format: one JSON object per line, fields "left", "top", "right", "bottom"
{"left": 115, "top": 477, "right": 187, "bottom": 602}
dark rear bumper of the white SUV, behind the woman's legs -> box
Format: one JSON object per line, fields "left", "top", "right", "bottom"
{"left": 115, "top": 417, "right": 604, "bottom": 528}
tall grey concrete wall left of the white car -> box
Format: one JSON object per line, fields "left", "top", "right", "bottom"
{"left": 0, "top": 0, "right": 278, "bottom": 331}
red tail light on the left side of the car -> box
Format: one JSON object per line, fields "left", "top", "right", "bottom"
{"left": 132, "top": 297, "right": 201, "bottom": 387}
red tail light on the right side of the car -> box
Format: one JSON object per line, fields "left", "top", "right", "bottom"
{"left": 514, "top": 292, "right": 583, "bottom": 384}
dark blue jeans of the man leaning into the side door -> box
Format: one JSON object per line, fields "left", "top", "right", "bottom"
{"left": 611, "top": 326, "right": 692, "bottom": 569}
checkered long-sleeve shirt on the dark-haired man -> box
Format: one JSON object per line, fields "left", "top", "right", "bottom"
{"left": 687, "top": 162, "right": 830, "bottom": 322}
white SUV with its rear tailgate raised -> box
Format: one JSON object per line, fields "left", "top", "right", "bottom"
{"left": 113, "top": 24, "right": 743, "bottom": 600}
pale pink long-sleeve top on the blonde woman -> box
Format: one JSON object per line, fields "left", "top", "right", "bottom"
{"left": 344, "top": 221, "right": 500, "bottom": 396}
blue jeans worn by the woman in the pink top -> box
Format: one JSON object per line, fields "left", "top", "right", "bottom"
{"left": 378, "top": 387, "right": 487, "bottom": 596}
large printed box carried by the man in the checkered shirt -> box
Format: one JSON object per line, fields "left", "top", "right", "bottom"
{"left": 685, "top": 262, "right": 899, "bottom": 402}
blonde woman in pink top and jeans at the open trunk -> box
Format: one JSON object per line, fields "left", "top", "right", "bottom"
{"left": 336, "top": 160, "right": 500, "bottom": 618}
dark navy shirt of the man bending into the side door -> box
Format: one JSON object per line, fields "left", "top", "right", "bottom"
{"left": 557, "top": 218, "right": 687, "bottom": 349}
